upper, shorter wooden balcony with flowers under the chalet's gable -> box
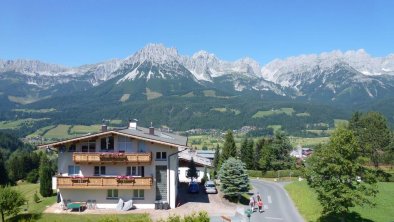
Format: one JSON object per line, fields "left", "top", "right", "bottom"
{"left": 73, "top": 152, "right": 152, "bottom": 164}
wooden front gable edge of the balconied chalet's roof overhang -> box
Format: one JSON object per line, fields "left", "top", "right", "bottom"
{"left": 37, "top": 130, "right": 186, "bottom": 149}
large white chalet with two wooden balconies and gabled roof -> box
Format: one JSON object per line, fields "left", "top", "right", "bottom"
{"left": 40, "top": 123, "right": 187, "bottom": 208}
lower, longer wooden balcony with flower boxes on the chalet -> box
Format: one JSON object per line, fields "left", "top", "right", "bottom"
{"left": 57, "top": 176, "right": 153, "bottom": 190}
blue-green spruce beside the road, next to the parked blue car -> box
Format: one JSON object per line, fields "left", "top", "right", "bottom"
{"left": 219, "top": 157, "right": 249, "bottom": 201}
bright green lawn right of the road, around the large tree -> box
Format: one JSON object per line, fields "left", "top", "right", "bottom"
{"left": 285, "top": 181, "right": 394, "bottom": 222}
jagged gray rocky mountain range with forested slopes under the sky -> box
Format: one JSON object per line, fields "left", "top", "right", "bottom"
{"left": 0, "top": 44, "right": 394, "bottom": 133}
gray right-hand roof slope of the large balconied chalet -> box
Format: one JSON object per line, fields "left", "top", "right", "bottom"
{"left": 116, "top": 126, "right": 187, "bottom": 146}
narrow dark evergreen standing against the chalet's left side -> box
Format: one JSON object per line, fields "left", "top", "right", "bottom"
{"left": 39, "top": 154, "right": 53, "bottom": 197}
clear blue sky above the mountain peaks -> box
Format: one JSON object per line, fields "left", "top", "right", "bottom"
{"left": 0, "top": 0, "right": 394, "bottom": 66}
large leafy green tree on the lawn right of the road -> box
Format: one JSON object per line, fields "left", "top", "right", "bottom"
{"left": 306, "top": 127, "right": 377, "bottom": 215}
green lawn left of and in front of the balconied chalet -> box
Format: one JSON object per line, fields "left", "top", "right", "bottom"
{"left": 7, "top": 183, "right": 151, "bottom": 222}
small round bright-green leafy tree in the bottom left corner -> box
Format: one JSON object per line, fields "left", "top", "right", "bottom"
{"left": 0, "top": 187, "right": 26, "bottom": 222}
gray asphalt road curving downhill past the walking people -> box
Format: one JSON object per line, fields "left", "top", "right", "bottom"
{"left": 250, "top": 180, "right": 304, "bottom": 222}
